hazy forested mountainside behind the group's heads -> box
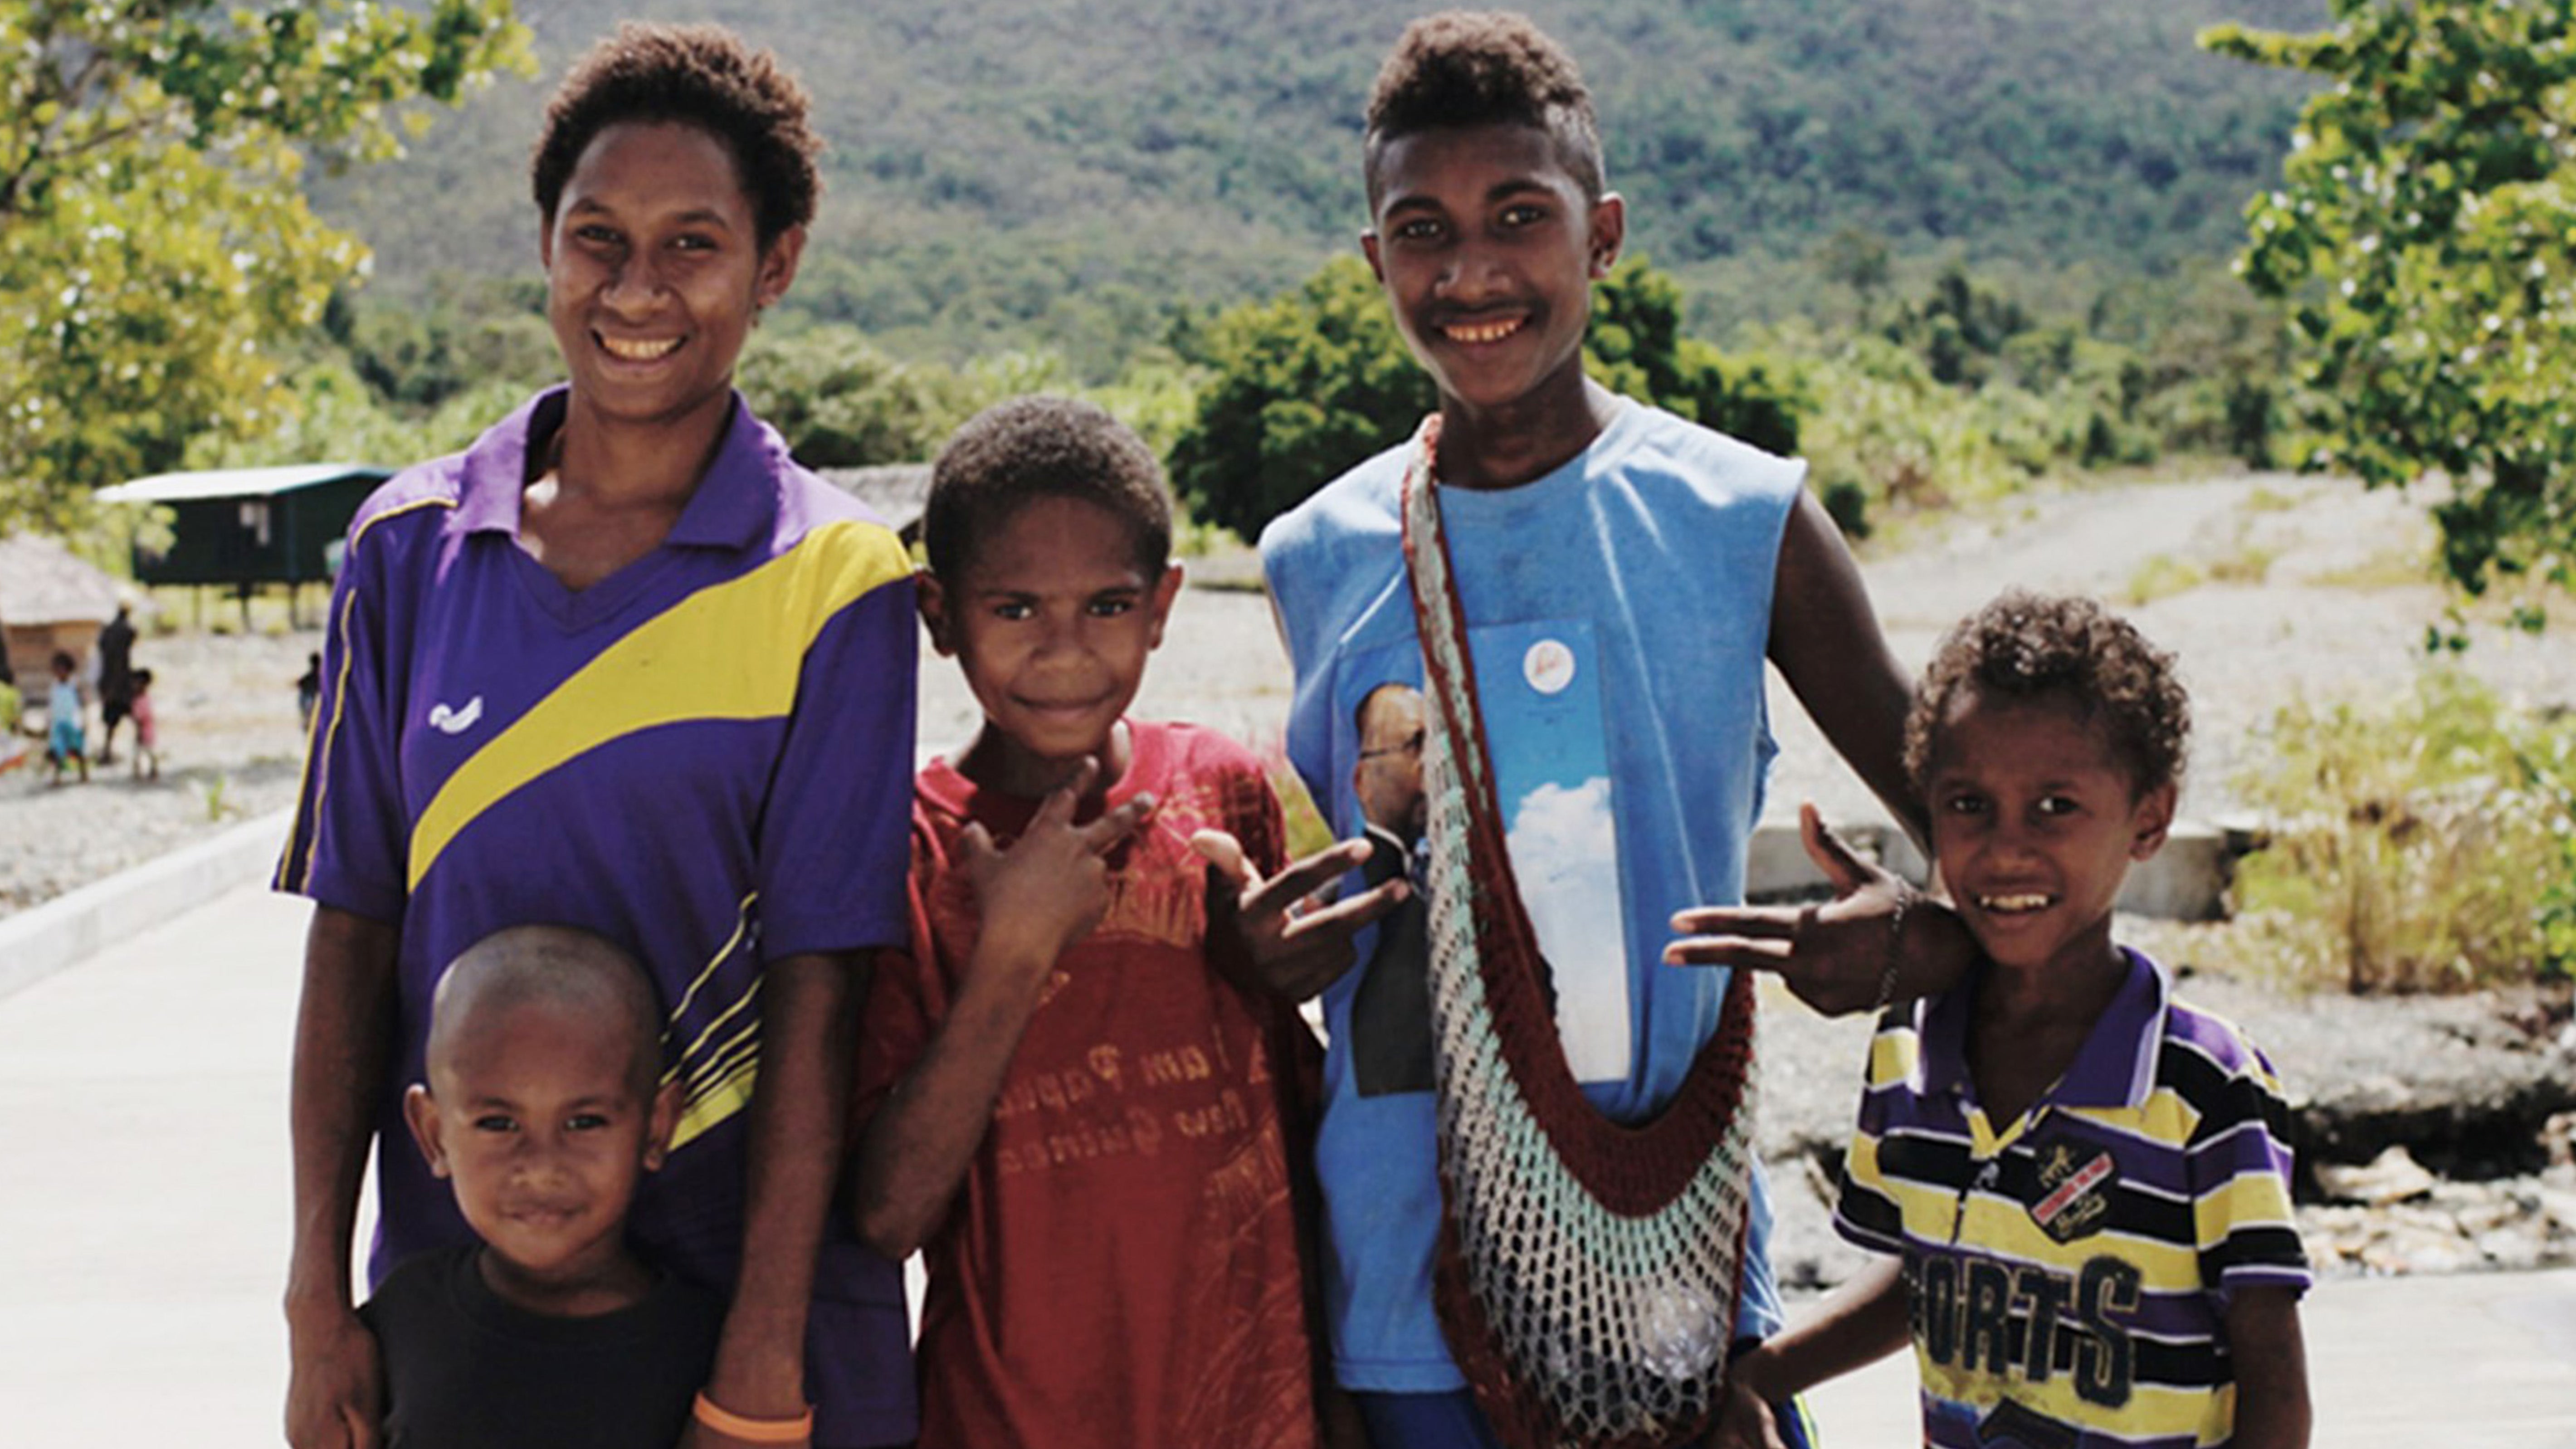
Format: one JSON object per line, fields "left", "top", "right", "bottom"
{"left": 317, "top": 0, "right": 2323, "bottom": 361}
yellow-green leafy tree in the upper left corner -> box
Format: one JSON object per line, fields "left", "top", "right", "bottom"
{"left": 0, "top": 0, "right": 533, "bottom": 526}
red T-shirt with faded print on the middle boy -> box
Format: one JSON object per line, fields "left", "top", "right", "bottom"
{"left": 858, "top": 725, "right": 1316, "bottom": 1449}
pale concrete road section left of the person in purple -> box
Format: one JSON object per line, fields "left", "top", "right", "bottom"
{"left": 0, "top": 884, "right": 309, "bottom": 1446}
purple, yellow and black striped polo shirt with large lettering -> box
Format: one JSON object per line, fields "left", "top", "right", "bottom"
{"left": 1834, "top": 951, "right": 2311, "bottom": 1449}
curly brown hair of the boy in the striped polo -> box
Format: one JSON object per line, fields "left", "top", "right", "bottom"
{"left": 1906, "top": 588, "right": 2192, "bottom": 794}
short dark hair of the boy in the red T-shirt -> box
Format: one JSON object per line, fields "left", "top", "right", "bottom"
{"left": 922, "top": 397, "right": 1172, "bottom": 580}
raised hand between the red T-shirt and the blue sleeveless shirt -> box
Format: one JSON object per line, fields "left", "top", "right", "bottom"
{"left": 1190, "top": 830, "right": 1412, "bottom": 1000}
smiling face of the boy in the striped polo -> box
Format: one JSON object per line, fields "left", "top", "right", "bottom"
{"left": 1924, "top": 686, "right": 2177, "bottom": 972}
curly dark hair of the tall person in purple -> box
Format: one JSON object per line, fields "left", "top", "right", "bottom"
{"left": 528, "top": 20, "right": 822, "bottom": 250}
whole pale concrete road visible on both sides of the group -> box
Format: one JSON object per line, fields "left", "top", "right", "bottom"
{"left": 0, "top": 887, "right": 2576, "bottom": 1449}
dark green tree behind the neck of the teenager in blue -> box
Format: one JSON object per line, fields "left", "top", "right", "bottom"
{"left": 1172, "top": 255, "right": 1803, "bottom": 539}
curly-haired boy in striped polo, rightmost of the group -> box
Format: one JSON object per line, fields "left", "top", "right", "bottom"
{"left": 1718, "top": 590, "right": 2311, "bottom": 1449}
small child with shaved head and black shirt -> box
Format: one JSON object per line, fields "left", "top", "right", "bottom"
{"left": 361, "top": 926, "right": 724, "bottom": 1449}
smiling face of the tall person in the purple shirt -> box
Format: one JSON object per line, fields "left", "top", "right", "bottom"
{"left": 541, "top": 121, "right": 804, "bottom": 446}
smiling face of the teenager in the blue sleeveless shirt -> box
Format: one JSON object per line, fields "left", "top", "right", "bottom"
{"left": 1360, "top": 121, "right": 1625, "bottom": 456}
